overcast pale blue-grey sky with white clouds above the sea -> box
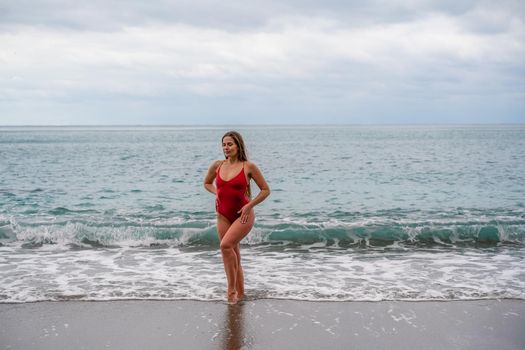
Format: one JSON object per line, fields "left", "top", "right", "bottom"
{"left": 0, "top": 0, "right": 525, "bottom": 125}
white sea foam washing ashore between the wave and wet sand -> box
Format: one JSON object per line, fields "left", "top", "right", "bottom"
{"left": 0, "top": 246, "right": 525, "bottom": 302}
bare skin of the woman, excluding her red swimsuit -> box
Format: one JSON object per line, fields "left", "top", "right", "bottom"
{"left": 204, "top": 136, "right": 270, "bottom": 304}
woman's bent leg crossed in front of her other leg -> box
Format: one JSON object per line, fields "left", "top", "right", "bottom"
{"left": 221, "top": 211, "right": 255, "bottom": 302}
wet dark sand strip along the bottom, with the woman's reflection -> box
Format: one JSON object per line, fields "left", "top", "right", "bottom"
{"left": 0, "top": 300, "right": 525, "bottom": 350}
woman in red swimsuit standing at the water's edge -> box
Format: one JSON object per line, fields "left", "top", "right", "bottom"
{"left": 204, "top": 131, "right": 270, "bottom": 304}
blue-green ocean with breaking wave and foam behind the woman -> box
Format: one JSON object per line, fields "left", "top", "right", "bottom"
{"left": 0, "top": 125, "right": 525, "bottom": 303}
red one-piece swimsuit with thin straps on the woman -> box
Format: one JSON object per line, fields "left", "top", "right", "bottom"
{"left": 215, "top": 162, "right": 250, "bottom": 223}
